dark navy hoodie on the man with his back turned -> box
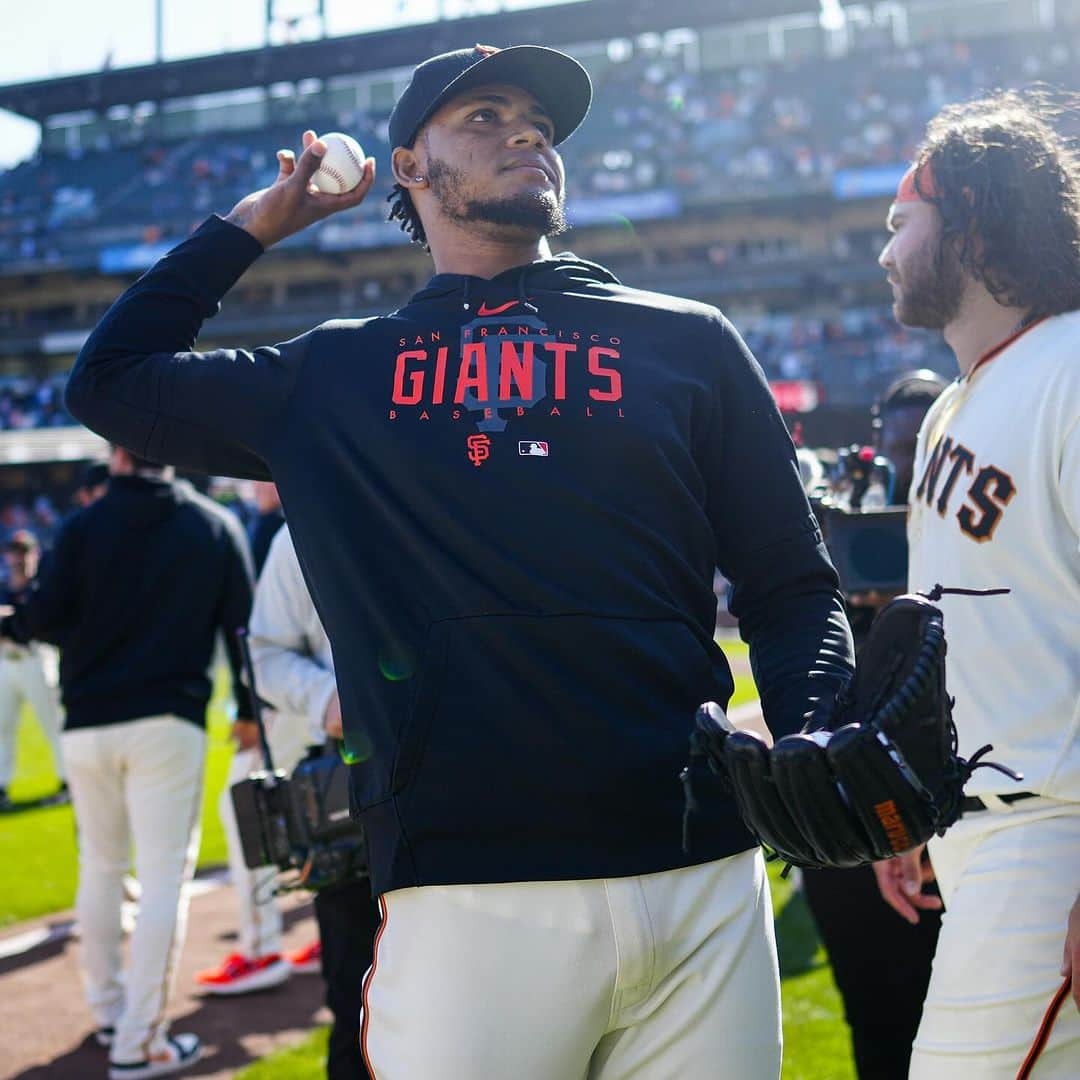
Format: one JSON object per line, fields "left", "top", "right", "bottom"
{"left": 2, "top": 475, "right": 252, "bottom": 731}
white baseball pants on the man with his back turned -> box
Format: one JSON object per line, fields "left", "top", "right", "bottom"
{"left": 63, "top": 716, "right": 206, "bottom": 1064}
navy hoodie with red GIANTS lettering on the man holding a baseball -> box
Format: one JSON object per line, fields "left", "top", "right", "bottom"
{"left": 67, "top": 218, "right": 851, "bottom": 893}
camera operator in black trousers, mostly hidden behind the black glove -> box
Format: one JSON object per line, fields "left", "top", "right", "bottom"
{"left": 802, "top": 369, "right": 947, "bottom": 1080}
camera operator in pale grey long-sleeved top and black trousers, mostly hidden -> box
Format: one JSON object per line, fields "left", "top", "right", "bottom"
{"left": 251, "top": 526, "right": 379, "bottom": 1080}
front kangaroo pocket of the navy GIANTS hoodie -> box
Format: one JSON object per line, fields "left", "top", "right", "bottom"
{"left": 393, "top": 616, "right": 731, "bottom": 843}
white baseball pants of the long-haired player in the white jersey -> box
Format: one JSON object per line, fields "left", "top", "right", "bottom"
{"left": 910, "top": 798, "right": 1080, "bottom": 1080}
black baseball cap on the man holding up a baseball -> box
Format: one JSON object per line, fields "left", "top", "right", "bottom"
{"left": 390, "top": 45, "right": 593, "bottom": 149}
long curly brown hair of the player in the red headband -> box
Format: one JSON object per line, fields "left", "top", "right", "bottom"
{"left": 915, "top": 89, "right": 1080, "bottom": 318}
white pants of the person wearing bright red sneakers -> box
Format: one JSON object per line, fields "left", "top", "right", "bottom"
{"left": 217, "top": 713, "right": 308, "bottom": 959}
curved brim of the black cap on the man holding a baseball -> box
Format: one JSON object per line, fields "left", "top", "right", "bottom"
{"left": 408, "top": 45, "right": 593, "bottom": 146}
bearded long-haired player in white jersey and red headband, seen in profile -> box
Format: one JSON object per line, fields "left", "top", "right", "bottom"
{"left": 875, "top": 93, "right": 1080, "bottom": 1080}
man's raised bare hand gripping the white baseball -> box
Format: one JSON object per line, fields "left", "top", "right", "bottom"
{"left": 226, "top": 131, "right": 375, "bottom": 247}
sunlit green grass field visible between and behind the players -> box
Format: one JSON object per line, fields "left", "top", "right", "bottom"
{"left": 0, "top": 639, "right": 855, "bottom": 1080}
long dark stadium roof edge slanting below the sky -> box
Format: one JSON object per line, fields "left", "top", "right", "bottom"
{"left": 0, "top": 0, "right": 818, "bottom": 121}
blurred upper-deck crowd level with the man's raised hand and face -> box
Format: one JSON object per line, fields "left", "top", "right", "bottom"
{"left": 0, "top": 31, "right": 1080, "bottom": 261}
